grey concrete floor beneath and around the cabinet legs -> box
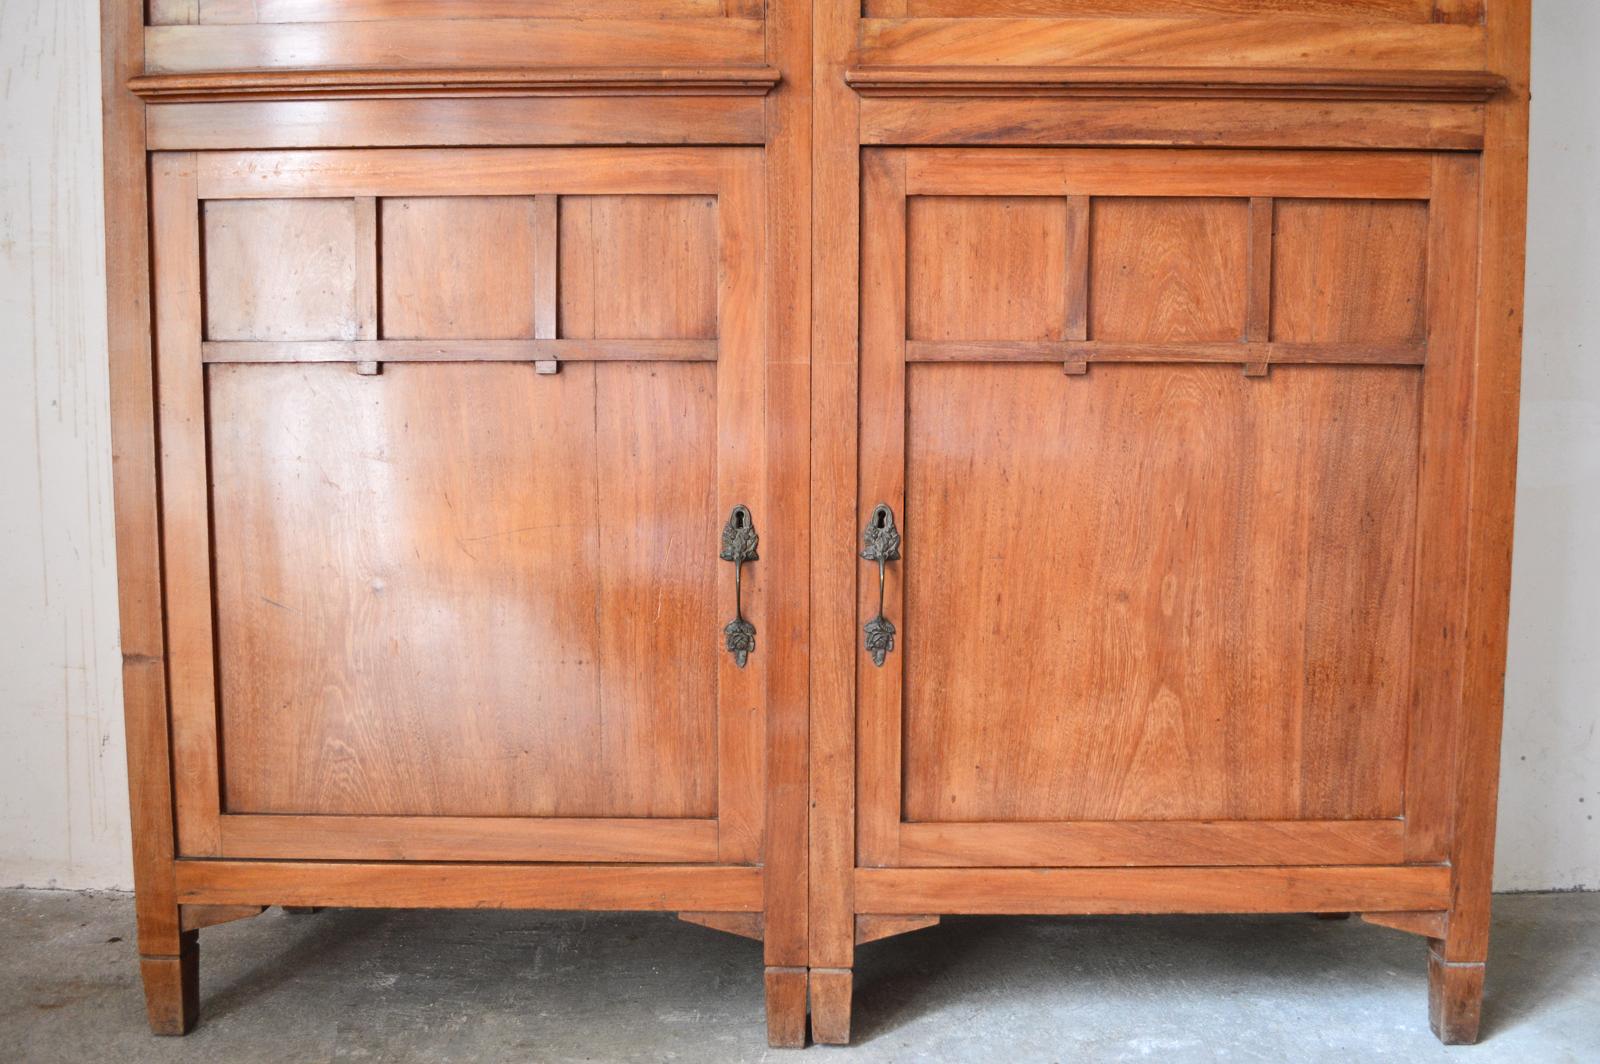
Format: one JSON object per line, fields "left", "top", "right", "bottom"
{"left": 0, "top": 891, "right": 1600, "bottom": 1064}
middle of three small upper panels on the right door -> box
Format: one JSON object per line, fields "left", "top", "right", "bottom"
{"left": 1090, "top": 197, "right": 1250, "bottom": 342}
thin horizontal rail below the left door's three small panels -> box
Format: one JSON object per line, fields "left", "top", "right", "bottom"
{"left": 200, "top": 339, "right": 717, "bottom": 365}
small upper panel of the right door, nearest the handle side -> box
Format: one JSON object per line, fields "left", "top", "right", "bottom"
{"left": 906, "top": 197, "right": 1067, "bottom": 341}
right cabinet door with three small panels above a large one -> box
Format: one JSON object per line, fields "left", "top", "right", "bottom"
{"left": 858, "top": 149, "right": 1477, "bottom": 867}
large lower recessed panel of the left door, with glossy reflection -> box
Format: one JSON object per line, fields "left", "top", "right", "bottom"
{"left": 208, "top": 363, "right": 718, "bottom": 818}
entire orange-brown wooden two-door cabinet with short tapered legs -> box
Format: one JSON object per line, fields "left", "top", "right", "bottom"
{"left": 106, "top": 0, "right": 1528, "bottom": 1045}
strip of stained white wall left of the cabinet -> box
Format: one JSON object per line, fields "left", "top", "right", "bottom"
{"left": 0, "top": 0, "right": 133, "bottom": 886}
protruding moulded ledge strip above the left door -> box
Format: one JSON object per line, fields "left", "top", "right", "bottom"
{"left": 128, "top": 67, "right": 779, "bottom": 102}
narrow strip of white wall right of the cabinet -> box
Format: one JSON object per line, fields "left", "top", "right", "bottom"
{"left": 1496, "top": 0, "right": 1600, "bottom": 890}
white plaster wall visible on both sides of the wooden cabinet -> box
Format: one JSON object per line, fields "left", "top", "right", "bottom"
{"left": 0, "top": 0, "right": 1600, "bottom": 890}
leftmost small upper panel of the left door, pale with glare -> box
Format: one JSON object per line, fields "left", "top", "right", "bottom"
{"left": 202, "top": 200, "right": 358, "bottom": 341}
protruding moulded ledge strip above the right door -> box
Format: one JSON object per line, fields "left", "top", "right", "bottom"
{"left": 845, "top": 66, "right": 1506, "bottom": 102}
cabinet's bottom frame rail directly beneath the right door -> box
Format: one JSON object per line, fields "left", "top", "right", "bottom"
{"left": 854, "top": 866, "right": 1450, "bottom": 915}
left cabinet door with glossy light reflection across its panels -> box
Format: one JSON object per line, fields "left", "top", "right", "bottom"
{"left": 152, "top": 149, "right": 768, "bottom": 864}
